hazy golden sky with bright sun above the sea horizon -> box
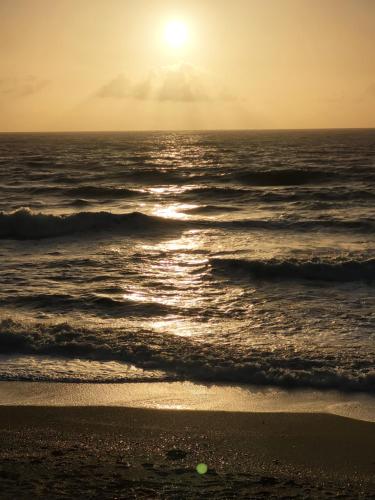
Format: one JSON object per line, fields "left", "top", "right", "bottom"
{"left": 0, "top": 0, "right": 375, "bottom": 131}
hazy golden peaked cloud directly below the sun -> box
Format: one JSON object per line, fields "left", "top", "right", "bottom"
{"left": 96, "top": 63, "right": 234, "bottom": 102}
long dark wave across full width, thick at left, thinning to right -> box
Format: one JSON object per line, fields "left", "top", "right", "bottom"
{"left": 0, "top": 208, "right": 375, "bottom": 240}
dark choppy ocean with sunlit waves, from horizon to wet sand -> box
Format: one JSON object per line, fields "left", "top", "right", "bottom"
{"left": 0, "top": 130, "right": 375, "bottom": 392}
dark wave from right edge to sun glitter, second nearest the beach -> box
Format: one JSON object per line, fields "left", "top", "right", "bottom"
{"left": 210, "top": 258, "right": 375, "bottom": 283}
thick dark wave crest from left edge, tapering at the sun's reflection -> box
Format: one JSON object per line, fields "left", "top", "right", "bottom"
{"left": 0, "top": 208, "right": 182, "bottom": 240}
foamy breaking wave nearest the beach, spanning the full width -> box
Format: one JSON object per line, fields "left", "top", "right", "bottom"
{"left": 0, "top": 318, "right": 375, "bottom": 393}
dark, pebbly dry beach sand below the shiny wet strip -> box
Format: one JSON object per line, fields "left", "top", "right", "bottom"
{"left": 0, "top": 407, "right": 375, "bottom": 500}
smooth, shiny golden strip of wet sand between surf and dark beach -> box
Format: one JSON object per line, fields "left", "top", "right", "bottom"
{"left": 0, "top": 381, "right": 375, "bottom": 422}
